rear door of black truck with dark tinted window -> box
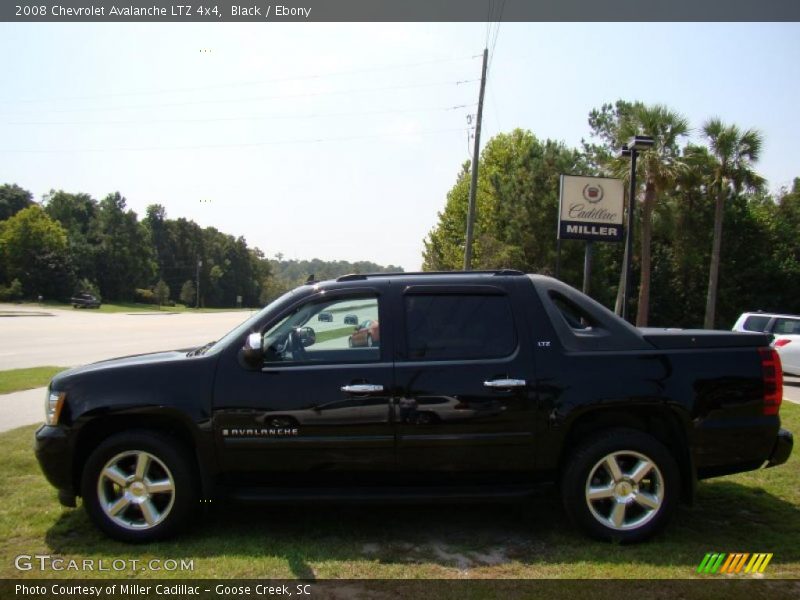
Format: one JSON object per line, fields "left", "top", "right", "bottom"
{"left": 394, "top": 285, "right": 535, "bottom": 481}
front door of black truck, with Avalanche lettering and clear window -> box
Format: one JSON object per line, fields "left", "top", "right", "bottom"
{"left": 213, "top": 290, "right": 395, "bottom": 485}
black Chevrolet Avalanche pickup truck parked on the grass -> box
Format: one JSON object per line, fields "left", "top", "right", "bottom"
{"left": 36, "top": 270, "right": 792, "bottom": 542}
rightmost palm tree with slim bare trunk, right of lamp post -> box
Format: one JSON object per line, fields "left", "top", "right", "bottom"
{"left": 703, "top": 118, "right": 765, "bottom": 329}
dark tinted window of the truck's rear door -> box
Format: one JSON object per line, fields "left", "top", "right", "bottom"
{"left": 405, "top": 294, "right": 517, "bottom": 360}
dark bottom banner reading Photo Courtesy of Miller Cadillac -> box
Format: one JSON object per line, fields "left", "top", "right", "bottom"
{"left": 0, "top": 577, "right": 800, "bottom": 600}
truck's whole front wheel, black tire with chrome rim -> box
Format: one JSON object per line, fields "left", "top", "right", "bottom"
{"left": 81, "top": 430, "right": 199, "bottom": 542}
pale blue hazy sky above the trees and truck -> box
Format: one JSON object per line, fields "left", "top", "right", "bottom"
{"left": 0, "top": 23, "right": 800, "bottom": 269}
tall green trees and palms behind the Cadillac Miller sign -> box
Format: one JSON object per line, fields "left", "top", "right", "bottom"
{"left": 423, "top": 100, "right": 800, "bottom": 328}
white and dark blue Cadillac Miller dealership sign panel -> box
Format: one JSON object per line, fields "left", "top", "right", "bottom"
{"left": 558, "top": 175, "right": 623, "bottom": 242}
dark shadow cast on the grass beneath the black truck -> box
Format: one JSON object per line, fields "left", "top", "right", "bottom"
{"left": 45, "top": 480, "right": 800, "bottom": 579}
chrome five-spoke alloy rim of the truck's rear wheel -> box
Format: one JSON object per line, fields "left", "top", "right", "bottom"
{"left": 586, "top": 450, "right": 664, "bottom": 531}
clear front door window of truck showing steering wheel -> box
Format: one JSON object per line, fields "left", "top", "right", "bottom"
{"left": 262, "top": 296, "right": 381, "bottom": 365}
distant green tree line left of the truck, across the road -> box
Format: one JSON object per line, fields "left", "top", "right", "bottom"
{"left": 0, "top": 184, "right": 396, "bottom": 307}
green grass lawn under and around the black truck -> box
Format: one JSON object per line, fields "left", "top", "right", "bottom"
{"left": 0, "top": 404, "right": 800, "bottom": 580}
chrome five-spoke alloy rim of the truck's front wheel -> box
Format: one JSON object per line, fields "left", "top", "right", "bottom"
{"left": 97, "top": 450, "right": 175, "bottom": 530}
